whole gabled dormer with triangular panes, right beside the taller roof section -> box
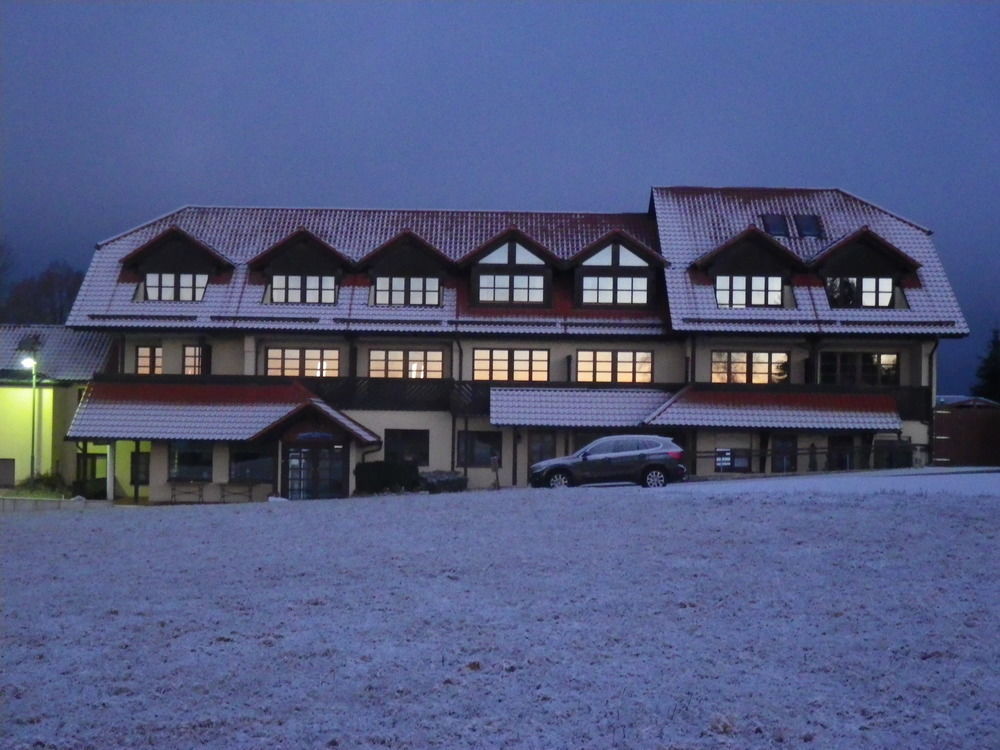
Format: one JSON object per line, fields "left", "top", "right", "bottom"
{"left": 575, "top": 232, "right": 664, "bottom": 307}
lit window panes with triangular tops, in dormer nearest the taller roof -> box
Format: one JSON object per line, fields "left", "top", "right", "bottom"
{"left": 577, "top": 242, "right": 651, "bottom": 305}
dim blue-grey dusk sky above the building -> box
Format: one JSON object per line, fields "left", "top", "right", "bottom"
{"left": 0, "top": 0, "right": 1000, "bottom": 393}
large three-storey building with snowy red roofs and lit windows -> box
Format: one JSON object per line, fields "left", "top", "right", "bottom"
{"left": 56, "top": 187, "right": 968, "bottom": 502}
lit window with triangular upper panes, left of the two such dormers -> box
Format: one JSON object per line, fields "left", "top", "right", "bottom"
{"left": 473, "top": 240, "right": 551, "bottom": 305}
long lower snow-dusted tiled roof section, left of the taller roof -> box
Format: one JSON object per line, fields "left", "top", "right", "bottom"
{"left": 68, "top": 206, "right": 664, "bottom": 335}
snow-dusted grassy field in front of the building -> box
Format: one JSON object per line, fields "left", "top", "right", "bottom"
{"left": 0, "top": 470, "right": 1000, "bottom": 750}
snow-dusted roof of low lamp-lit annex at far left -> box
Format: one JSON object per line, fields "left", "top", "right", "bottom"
{"left": 0, "top": 324, "right": 111, "bottom": 381}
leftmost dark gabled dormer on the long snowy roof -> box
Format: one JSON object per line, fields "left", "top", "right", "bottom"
{"left": 118, "top": 226, "right": 233, "bottom": 302}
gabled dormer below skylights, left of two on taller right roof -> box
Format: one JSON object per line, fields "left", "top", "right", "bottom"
{"left": 691, "top": 224, "right": 805, "bottom": 308}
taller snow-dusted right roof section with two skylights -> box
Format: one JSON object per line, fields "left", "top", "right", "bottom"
{"left": 652, "top": 187, "right": 969, "bottom": 336}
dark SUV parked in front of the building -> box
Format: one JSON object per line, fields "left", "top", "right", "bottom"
{"left": 529, "top": 435, "right": 687, "bottom": 487}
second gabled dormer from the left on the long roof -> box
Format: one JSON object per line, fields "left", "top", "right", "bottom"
{"left": 249, "top": 232, "right": 350, "bottom": 305}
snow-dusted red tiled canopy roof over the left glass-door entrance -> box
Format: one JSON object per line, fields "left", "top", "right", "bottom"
{"left": 66, "top": 382, "right": 380, "bottom": 445}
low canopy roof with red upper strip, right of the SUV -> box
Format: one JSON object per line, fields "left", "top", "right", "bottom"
{"left": 646, "top": 388, "right": 902, "bottom": 432}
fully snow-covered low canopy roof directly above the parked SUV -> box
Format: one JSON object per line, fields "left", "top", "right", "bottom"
{"left": 490, "top": 388, "right": 670, "bottom": 427}
